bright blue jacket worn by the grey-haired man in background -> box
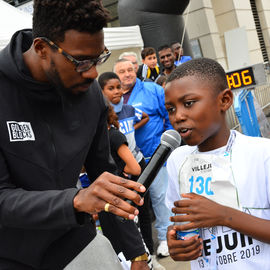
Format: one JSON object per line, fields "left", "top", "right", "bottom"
{"left": 125, "top": 79, "right": 173, "bottom": 159}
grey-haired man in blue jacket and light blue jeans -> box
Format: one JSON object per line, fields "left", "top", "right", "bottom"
{"left": 114, "top": 59, "right": 172, "bottom": 256}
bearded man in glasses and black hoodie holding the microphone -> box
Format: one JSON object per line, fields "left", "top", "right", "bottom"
{"left": 0, "top": 0, "right": 147, "bottom": 270}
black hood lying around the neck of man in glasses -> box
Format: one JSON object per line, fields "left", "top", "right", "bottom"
{"left": 0, "top": 29, "right": 61, "bottom": 102}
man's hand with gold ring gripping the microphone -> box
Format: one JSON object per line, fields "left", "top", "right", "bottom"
{"left": 73, "top": 172, "right": 145, "bottom": 219}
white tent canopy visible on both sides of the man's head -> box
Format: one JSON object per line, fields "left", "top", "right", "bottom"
{"left": 0, "top": 0, "right": 143, "bottom": 50}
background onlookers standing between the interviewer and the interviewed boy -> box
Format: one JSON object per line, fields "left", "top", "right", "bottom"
{"left": 80, "top": 42, "right": 190, "bottom": 270}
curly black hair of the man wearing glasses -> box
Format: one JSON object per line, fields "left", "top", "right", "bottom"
{"left": 33, "top": 0, "right": 109, "bottom": 41}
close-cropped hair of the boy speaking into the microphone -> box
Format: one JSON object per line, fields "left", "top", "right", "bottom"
{"left": 166, "top": 58, "right": 228, "bottom": 92}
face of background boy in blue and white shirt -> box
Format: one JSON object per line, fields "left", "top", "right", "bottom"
{"left": 103, "top": 79, "right": 123, "bottom": 104}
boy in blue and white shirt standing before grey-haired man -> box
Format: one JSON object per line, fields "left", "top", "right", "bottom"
{"left": 98, "top": 72, "right": 166, "bottom": 270}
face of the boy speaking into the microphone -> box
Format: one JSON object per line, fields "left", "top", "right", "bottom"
{"left": 165, "top": 76, "right": 232, "bottom": 151}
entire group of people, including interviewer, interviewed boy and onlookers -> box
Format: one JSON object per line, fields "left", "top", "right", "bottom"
{"left": 0, "top": 0, "right": 270, "bottom": 270}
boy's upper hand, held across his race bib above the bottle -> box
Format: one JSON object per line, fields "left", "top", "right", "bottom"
{"left": 170, "top": 193, "right": 227, "bottom": 231}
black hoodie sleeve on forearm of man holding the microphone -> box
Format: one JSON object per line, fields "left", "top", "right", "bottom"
{"left": 0, "top": 148, "right": 82, "bottom": 230}
